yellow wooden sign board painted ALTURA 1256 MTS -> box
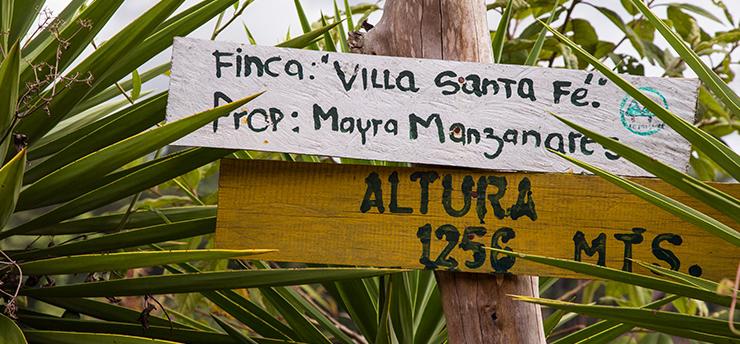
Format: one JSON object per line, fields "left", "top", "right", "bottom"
{"left": 216, "top": 160, "right": 740, "bottom": 280}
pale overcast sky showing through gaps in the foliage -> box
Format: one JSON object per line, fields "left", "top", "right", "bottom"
{"left": 46, "top": 0, "right": 740, "bottom": 150}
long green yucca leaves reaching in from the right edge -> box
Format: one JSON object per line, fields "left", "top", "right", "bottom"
{"left": 492, "top": 0, "right": 740, "bottom": 343}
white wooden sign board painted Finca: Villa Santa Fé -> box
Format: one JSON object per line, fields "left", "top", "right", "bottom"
{"left": 167, "top": 38, "right": 698, "bottom": 176}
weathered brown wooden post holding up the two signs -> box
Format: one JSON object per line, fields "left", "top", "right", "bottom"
{"left": 349, "top": 0, "right": 545, "bottom": 344}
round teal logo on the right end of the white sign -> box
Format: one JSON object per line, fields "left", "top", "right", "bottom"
{"left": 619, "top": 87, "right": 668, "bottom": 136}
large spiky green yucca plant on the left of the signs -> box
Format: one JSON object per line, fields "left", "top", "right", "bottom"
{"left": 0, "top": 0, "right": 404, "bottom": 343}
